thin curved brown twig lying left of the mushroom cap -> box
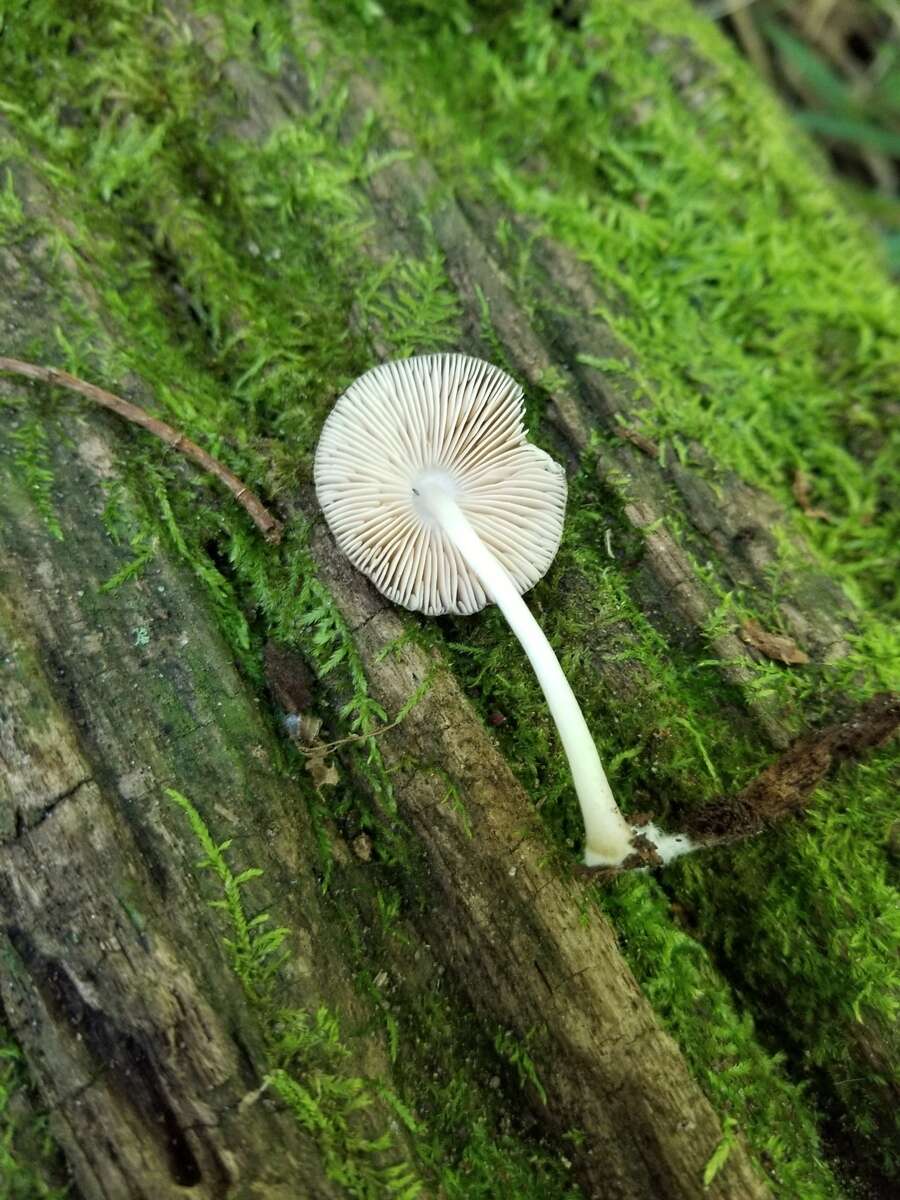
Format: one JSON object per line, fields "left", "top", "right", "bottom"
{"left": 0, "top": 356, "right": 284, "bottom": 542}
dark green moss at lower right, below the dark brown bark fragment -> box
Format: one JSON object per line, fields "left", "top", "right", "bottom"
{"left": 666, "top": 751, "right": 900, "bottom": 1176}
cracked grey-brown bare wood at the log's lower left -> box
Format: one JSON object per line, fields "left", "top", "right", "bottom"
{"left": 0, "top": 220, "right": 403, "bottom": 1200}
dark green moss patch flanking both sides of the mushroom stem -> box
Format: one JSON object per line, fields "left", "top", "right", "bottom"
{"left": 443, "top": 458, "right": 767, "bottom": 848}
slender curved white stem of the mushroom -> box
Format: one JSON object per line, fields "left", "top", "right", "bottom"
{"left": 415, "top": 478, "right": 635, "bottom": 866}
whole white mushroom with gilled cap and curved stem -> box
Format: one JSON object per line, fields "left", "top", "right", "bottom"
{"left": 316, "top": 354, "right": 688, "bottom": 866}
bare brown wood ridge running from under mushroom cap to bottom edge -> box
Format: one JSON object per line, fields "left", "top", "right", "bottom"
{"left": 313, "top": 527, "right": 768, "bottom": 1200}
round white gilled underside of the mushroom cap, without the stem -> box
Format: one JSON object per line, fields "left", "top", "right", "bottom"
{"left": 314, "top": 354, "right": 566, "bottom": 616}
